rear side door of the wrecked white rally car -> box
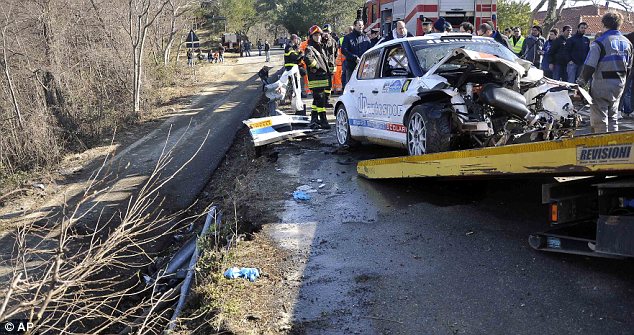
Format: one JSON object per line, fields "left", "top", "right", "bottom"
{"left": 346, "top": 49, "right": 381, "bottom": 138}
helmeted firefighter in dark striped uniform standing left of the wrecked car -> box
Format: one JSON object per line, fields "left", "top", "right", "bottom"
{"left": 304, "top": 25, "right": 331, "bottom": 129}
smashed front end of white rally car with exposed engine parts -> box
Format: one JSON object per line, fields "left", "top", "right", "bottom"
{"left": 419, "top": 48, "right": 589, "bottom": 147}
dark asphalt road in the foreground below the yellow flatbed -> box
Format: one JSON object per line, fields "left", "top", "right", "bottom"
{"left": 262, "top": 124, "right": 634, "bottom": 334}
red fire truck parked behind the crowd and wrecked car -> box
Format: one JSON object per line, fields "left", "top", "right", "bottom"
{"left": 363, "top": 0, "right": 497, "bottom": 36}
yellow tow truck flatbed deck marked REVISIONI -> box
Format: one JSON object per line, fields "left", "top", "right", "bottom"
{"left": 357, "top": 130, "right": 634, "bottom": 179}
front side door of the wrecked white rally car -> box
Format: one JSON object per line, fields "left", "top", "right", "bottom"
{"left": 368, "top": 43, "right": 413, "bottom": 145}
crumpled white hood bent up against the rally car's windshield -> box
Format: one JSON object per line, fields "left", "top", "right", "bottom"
{"left": 425, "top": 48, "right": 530, "bottom": 78}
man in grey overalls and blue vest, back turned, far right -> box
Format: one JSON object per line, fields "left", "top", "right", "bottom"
{"left": 577, "top": 13, "right": 632, "bottom": 133}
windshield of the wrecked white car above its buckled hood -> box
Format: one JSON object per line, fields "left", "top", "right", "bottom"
{"left": 410, "top": 39, "right": 517, "bottom": 72}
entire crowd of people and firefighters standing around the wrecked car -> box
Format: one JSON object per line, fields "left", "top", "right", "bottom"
{"left": 284, "top": 12, "right": 634, "bottom": 132}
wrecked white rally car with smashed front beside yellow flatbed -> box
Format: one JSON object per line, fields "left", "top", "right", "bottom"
{"left": 335, "top": 33, "right": 590, "bottom": 155}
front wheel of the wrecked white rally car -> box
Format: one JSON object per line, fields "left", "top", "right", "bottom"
{"left": 406, "top": 103, "right": 451, "bottom": 156}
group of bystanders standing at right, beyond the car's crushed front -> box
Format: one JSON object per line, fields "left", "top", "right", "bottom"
{"left": 496, "top": 12, "right": 634, "bottom": 132}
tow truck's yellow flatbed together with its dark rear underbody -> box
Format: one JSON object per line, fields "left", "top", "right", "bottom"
{"left": 357, "top": 131, "right": 634, "bottom": 258}
